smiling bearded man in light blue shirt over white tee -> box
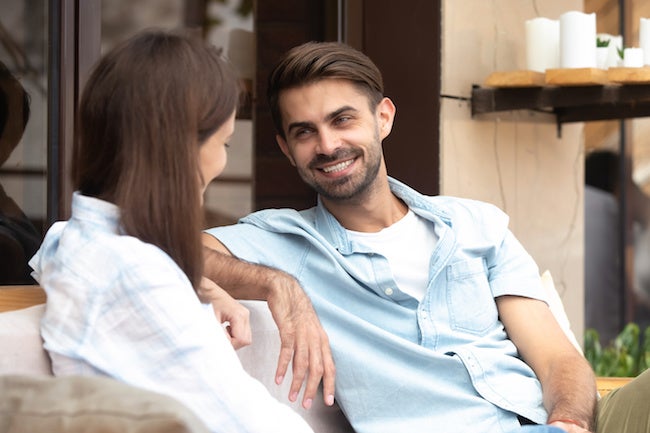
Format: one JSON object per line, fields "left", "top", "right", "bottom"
{"left": 204, "top": 43, "right": 644, "bottom": 433}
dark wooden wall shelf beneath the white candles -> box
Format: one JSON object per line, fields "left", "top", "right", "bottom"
{"left": 471, "top": 84, "right": 650, "bottom": 125}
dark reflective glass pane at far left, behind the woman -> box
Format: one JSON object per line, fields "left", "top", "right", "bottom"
{"left": 0, "top": 0, "right": 49, "bottom": 284}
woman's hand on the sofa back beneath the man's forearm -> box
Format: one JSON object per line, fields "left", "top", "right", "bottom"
{"left": 198, "top": 277, "right": 252, "bottom": 350}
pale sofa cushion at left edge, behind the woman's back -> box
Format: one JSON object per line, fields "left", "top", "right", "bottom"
{"left": 0, "top": 304, "right": 52, "bottom": 375}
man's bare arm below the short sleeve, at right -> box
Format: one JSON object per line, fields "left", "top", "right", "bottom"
{"left": 497, "top": 296, "right": 597, "bottom": 433}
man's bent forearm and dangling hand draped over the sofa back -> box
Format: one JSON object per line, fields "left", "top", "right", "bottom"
{"left": 203, "top": 233, "right": 336, "bottom": 409}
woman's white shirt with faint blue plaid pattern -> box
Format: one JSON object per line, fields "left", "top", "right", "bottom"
{"left": 30, "top": 193, "right": 311, "bottom": 432}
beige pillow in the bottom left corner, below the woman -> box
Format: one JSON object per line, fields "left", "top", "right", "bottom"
{"left": 0, "top": 375, "right": 208, "bottom": 433}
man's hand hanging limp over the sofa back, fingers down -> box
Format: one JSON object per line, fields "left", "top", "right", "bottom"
{"left": 267, "top": 274, "right": 336, "bottom": 409}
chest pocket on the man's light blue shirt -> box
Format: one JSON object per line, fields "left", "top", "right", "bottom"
{"left": 447, "top": 257, "right": 498, "bottom": 335}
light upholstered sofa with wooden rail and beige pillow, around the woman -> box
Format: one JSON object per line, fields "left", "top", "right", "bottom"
{"left": 0, "top": 287, "right": 353, "bottom": 433}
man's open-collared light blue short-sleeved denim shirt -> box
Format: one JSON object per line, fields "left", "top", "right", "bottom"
{"left": 207, "top": 179, "right": 547, "bottom": 433}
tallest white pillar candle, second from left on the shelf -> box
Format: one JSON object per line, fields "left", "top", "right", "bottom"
{"left": 560, "top": 11, "right": 596, "bottom": 68}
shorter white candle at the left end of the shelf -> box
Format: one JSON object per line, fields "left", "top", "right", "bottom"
{"left": 526, "top": 17, "right": 560, "bottom": 72}
